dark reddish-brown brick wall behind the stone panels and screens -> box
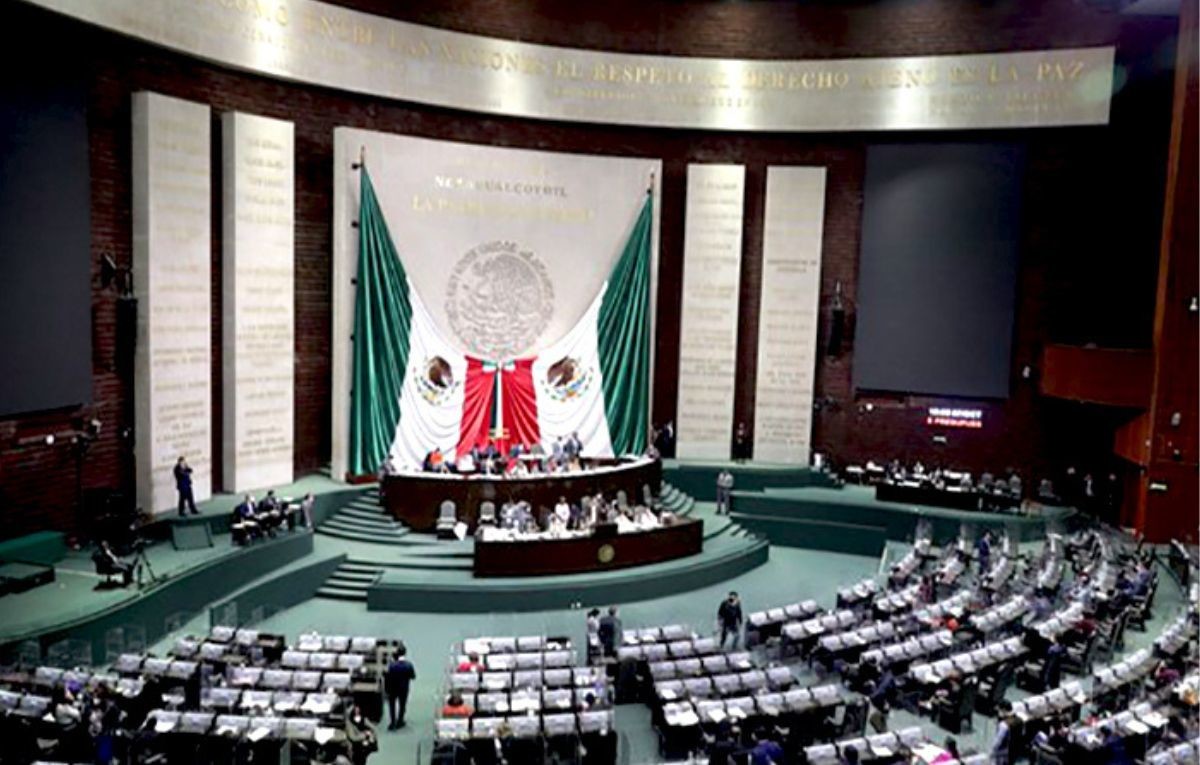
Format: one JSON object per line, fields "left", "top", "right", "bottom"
{"left": 0, "top": 0, "right": 1174, "bottom": 536}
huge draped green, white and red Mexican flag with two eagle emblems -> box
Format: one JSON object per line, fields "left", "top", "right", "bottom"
{"left": 349, "top": 165, "right": 653, "bottom": 475}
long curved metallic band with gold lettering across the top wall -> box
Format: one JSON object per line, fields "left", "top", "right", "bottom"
{"left": 28, "top": 0, "right": 1115, "bottom": 132}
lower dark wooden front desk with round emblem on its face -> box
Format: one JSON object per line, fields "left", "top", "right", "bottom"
{"left": 475, "top": 518, "right": 704, "bottom": 577}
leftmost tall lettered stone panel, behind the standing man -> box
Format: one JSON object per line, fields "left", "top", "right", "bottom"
{"left": 132, "top": 91, "right": 212, "bottom": 513}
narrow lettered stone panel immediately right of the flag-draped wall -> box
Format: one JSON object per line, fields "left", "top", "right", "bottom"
{"left": 676, "top": 164, "right": 745, "bottom": 459}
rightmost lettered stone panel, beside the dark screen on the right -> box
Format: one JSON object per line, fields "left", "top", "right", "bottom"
{"left": 754, "top": 167, "right": 826, "bottom": 464}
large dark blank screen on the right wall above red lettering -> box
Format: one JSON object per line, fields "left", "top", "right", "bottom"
{"left": 854, "top": 144, "right": 1024, "bottom": 398}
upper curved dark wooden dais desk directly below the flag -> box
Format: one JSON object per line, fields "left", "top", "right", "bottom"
{"left": 379, "top": 458, "right": 662, "bottom": 531}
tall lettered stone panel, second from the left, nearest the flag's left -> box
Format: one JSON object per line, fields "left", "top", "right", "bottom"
{"left": 221, "top": 112, "right": 295, "bottom": 492}
